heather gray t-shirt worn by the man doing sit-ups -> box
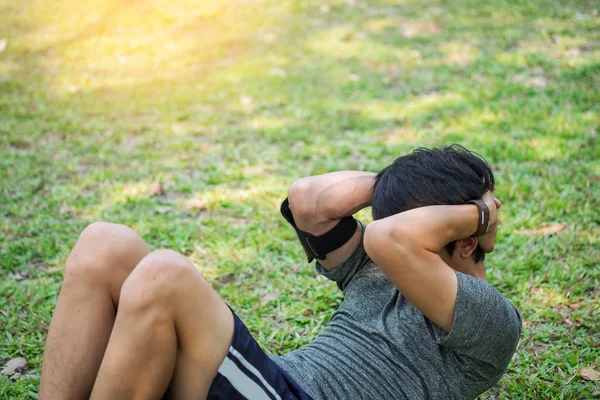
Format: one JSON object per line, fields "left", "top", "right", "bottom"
{"left": 272, "top": 226, "right": 521, "bottom": 400}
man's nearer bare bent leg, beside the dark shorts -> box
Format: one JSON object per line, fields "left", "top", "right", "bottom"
{"left": 91, "top": 250, "right": 233, "bottom": 400}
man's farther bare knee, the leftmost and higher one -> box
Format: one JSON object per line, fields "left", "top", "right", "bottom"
{"left": 65, "top": 222, "right": 149, "bottom": 278}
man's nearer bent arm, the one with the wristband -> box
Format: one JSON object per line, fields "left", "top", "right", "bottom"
{"left": 364, "top": 205, "right": 479, "bottom": 332}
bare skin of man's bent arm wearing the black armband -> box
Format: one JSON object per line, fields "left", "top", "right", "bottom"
{"left": 288, "top": 171, "right": 376, "bottom": 270}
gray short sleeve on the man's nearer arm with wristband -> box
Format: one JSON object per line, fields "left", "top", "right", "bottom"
{"left": 426, "top": 272, "right": 522, "bottom": 376}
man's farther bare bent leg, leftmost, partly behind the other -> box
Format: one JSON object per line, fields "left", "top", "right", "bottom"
{"left": 40, "top": 222, "right": 150, "bottom": 400}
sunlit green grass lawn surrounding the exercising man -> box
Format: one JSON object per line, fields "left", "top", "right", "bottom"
{"left": 0, "top": 0, "right": 600, "bottom": 399}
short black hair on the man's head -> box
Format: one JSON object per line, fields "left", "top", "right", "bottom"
{"left": 371, "top": 144, "right": 495, "bottom": 263}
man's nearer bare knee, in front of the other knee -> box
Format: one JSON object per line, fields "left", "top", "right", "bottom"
{"left": 119, "top": 250, "right": 202, "bottom": 315}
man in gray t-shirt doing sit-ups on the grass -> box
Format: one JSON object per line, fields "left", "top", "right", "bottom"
{"left": 40, "top": 146, "right": 521, "bottom": 400}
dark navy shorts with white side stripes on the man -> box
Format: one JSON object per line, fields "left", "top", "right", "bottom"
{"left": 207, "top": 310, "right": 312, "bottom": 400}
